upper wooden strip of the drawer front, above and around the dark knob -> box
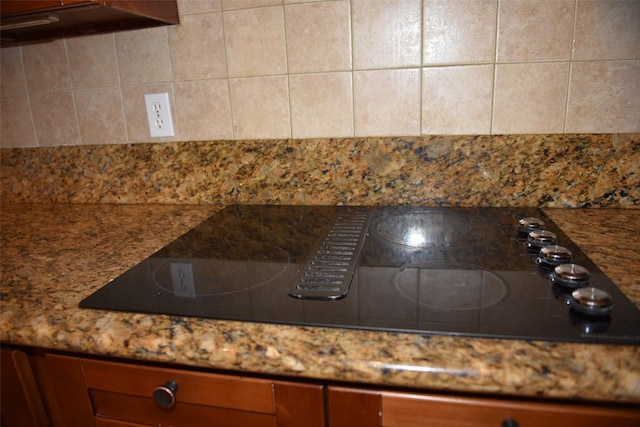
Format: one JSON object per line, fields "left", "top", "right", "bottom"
{"left": 82, "top": 360, "right": 275, "bottom": 414}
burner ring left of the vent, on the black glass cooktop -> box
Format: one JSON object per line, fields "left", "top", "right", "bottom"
{"left": 152, "top": 241, "right": 291, "bottom": 298}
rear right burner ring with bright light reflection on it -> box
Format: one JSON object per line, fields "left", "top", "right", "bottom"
{"left": 373, "top": 210, "right": 495, "bottom": 249}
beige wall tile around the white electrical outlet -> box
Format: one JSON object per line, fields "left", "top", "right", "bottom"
{"left": 122, "top": 84, "right": 180, "bottom": 142}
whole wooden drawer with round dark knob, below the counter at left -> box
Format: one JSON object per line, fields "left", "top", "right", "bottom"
{"left": 82, "top": 360, "right": 276, "bottom": 427}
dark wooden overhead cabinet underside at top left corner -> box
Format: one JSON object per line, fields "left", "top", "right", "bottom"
{"left": 0, "top": 0, "right": 180, "bottom": 47}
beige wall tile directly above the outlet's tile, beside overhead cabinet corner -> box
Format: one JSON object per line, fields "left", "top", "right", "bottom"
{"left": 115, "top": 27, "right": 172, "bottom": 85}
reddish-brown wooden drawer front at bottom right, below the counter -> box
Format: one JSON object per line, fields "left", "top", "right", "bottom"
{"left": 327, "top": 387, "right": 640, "bottom": 427}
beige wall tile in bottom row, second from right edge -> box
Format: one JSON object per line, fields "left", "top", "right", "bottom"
{"left": 492, "top": 62, "right": 569, "bottom": 134}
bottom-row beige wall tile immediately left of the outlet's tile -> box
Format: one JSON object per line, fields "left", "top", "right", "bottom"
{"left": 75, "top": 87, "right": 127, "bottom": 145}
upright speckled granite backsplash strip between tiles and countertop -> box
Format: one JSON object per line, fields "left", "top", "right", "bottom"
{"left": 0, "top": 134, "right": 640, "bottom": 208}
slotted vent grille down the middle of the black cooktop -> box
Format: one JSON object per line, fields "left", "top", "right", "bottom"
{"left": 288, "top": 210, "right": 370, "bottom": 300}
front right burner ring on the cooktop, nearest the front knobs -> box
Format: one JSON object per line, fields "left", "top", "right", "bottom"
{"left": 393, "top": 262, "right": 509, "bottom": 311}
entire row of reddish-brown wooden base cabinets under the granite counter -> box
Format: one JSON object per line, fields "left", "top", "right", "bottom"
{"left": 2, "top": 349, "right": 640, "bottom": 427}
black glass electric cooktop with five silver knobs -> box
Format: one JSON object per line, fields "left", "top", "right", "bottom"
{"left": 80, "top": 206, "right": 640, "bottom": 345}
